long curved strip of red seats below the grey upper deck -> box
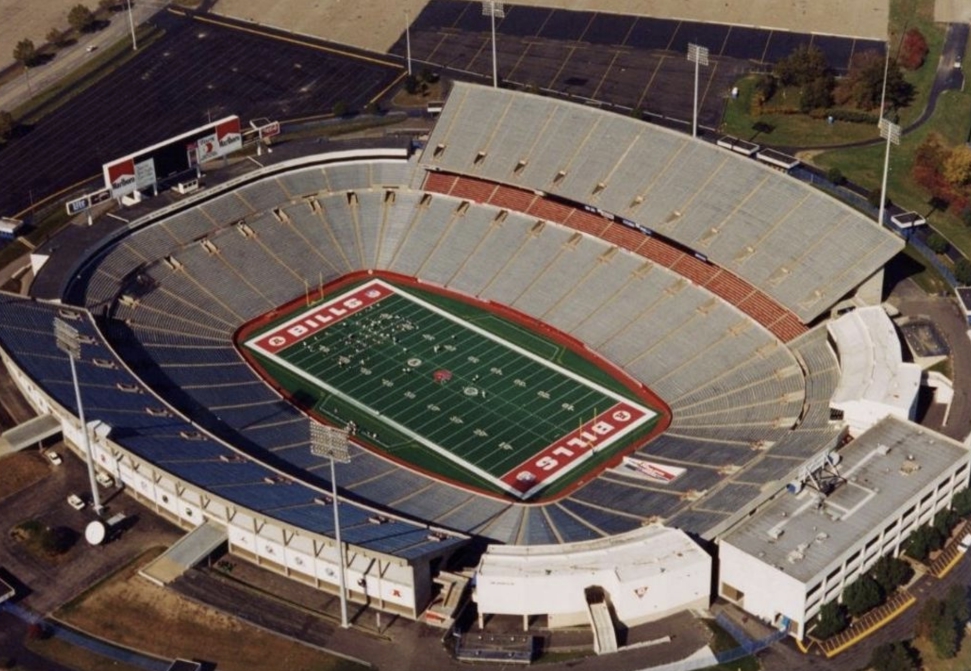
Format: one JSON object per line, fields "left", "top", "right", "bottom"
{"left": 424, "top": 171, "right": 806, "bottom": 342}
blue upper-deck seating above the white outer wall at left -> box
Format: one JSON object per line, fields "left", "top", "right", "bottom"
{"left": 0, "top": 294, "right": 465, "bottom": 559}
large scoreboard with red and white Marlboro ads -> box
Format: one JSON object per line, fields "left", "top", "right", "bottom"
{"left": 102, "top": 115, "right": 243, "bottom": 198}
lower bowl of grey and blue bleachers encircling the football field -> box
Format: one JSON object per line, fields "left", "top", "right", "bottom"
{"left": 62, "top": 163, "right": 844, "bottom": 544}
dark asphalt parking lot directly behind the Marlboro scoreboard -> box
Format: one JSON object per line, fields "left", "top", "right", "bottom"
{"left": 0, "top": 12, "right": 400, "bottom": 215}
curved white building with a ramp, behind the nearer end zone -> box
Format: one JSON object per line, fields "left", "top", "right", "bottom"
{"left": 475, "top": 525, "right": 712, "bottom": 627}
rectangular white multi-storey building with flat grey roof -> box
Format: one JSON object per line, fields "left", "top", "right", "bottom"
{"left": 718, "top": 416, "right": 971, "bottom": 639}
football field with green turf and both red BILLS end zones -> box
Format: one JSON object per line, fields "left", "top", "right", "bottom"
{"left": 244, "top": 279, "right": 660, "bottom": 499}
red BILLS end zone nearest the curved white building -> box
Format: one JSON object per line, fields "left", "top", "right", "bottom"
{"left": 500, "top": 401, "right": 654, "bottom": 499}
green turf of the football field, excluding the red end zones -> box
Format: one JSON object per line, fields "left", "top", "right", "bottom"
{"left": 247, "top": 276, "right": 662, "bottom": 496}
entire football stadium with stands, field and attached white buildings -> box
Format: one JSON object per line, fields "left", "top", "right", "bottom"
{"left": 0, "top": 77, "right": 969, "bottom": 650}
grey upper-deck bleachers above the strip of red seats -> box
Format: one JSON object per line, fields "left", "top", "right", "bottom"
{"left": 421, "top": 82, "right": 904, "bottom": 323}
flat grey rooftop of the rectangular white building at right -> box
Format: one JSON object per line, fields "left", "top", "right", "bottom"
{"left": 721, "top": 417, "right": 969, "bottom": 582}
